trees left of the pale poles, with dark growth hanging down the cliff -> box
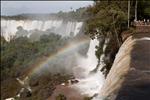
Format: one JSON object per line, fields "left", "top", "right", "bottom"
{"left": 86, "top": 0, "right": 127, "bottom": 75}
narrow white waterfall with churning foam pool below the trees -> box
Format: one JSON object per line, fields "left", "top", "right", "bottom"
{"left": 72, "top": 39, "right": 108, "bottom": 96}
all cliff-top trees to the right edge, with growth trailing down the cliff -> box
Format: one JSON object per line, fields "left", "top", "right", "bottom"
{"left": 85, "top": 0, "right": 150, "bottom": 75}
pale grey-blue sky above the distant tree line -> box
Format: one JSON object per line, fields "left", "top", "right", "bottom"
{"left": 1, "top": 1, "right": 93, "bottom": 15}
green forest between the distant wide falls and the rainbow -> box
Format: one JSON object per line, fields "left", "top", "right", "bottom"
{"left": 1, "top": 34, "right": 67, "bottom": 79}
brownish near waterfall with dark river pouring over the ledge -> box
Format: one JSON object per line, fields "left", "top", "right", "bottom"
{"left": 100, "top": 32, "right": 150, "bottom": 100}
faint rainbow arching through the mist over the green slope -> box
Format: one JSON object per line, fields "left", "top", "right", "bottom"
{"left": 28, "top": 39, "right": 89, "bottom": 76}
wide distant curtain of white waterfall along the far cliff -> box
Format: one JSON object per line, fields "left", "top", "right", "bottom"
{"left": 1, "top": 19, "right": 83, "bottom": 41}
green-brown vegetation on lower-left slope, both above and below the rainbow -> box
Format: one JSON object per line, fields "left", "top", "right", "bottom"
{"left": 1, "top": 33, "right": 72, "bottom": 100}
